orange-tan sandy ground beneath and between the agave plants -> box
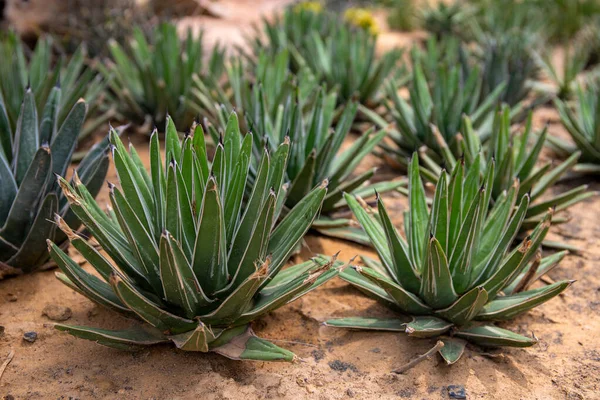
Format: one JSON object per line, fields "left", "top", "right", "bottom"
{"left": 0, "top": 0, "right": 600, "bottom": 400}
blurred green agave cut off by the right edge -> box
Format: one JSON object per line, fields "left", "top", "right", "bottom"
{"left": 550, "top": 80, "right": 600, "bottom": 174}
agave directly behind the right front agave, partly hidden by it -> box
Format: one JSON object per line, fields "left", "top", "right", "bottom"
{"left": 428, "top": 106, "right": 595, "bottom": 234}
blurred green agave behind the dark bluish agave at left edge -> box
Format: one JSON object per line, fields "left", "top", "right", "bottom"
{"left": 0, "top": 32, "right": 114, "bottom": 139}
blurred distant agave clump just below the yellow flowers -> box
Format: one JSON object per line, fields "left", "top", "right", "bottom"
{"left": 254, "top": 3, "right": 402, "bottom": 107}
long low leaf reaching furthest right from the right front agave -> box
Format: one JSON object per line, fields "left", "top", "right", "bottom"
{"left": 477, "top": 281, "right": 574, "bottom": 321}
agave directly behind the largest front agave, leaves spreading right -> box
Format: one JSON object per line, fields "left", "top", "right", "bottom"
{"left": 195, "top": 51, "right": 404, "bottom": 243}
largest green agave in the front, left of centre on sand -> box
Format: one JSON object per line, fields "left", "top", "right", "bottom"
{"left": 49, "top": 114, "right": 339, "bottom": 361}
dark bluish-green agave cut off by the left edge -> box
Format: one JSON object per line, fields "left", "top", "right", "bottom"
{"left": 0, "top": 86, "right": 108, "bottom": 278}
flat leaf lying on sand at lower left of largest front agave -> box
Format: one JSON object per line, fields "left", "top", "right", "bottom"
{"left": 54, "top": 324, "right": 169, "bottom": 350}
